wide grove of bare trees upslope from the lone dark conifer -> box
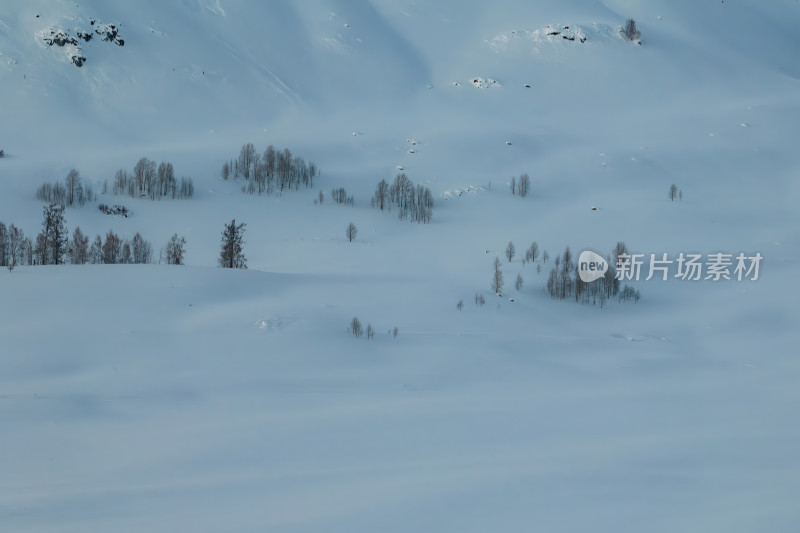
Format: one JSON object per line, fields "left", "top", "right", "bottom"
{"left": 221, "top": 143, "right": 318, "bottom": 195}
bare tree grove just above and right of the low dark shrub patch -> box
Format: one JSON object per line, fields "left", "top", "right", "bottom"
{"left": 108, "top": 157, "right": 194, "bottom": 200}
